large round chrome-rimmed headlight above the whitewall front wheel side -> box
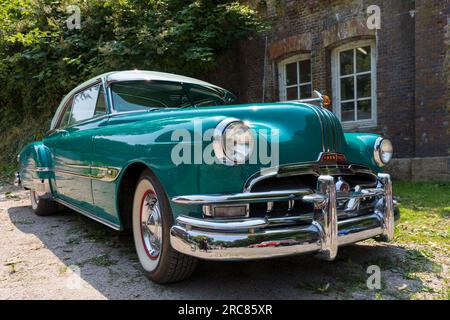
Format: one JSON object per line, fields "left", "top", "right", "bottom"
{"left": 213, "top": 118, "right": 254, "bottom": 165}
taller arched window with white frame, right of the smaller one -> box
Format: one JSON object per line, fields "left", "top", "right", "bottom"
{"left": 331, "top": 40, "right": 377, "bottom": 128}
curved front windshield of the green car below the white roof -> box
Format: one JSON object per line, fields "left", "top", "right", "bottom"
{"left": 111, "top": 81, "right": 234, "bottom": 112}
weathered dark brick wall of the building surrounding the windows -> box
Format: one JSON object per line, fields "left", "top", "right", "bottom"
{"left": 208, "top": 0, "right": 450, "bottom": 178}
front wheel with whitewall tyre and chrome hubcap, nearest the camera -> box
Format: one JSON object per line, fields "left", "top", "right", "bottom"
{"left": 133, "top": 170, "right": 197, "bottom": 283}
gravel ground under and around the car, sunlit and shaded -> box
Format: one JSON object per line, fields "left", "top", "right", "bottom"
{"left": 0, "top": 185, "right": 449, "bottom": 299}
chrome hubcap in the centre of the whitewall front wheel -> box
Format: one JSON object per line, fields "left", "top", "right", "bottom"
{"left": 141, "top": 193, "right": 162, "bottom": 260}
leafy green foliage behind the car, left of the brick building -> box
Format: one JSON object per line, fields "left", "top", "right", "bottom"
{"left": 0, "top": 0, "right": 265, "bottom": 162}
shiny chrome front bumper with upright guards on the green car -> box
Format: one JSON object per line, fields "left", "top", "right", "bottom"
{"left": 170, "top": 174, "right": 394, "bottom": 260}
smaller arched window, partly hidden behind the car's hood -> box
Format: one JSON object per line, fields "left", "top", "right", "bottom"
{"left": 278, "top": 54, "right": 313, "bottom": 101}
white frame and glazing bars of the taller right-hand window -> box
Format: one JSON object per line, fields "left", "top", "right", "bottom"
{"left": 331, "top": 40, "right": 378, "bottom": 129}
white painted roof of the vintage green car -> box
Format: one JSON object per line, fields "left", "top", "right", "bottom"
{"left": 50, "top": 70, "right": 229, "bottom": 130}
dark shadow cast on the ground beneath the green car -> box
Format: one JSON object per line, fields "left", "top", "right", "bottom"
{"left": 7, "top": 202, "right": 433, "bottom": 299}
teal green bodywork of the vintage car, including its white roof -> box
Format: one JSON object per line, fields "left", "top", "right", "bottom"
{"left": 15, "top": 72, "right": 398, "bottom": 282}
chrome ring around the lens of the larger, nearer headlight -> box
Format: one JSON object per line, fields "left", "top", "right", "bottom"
{"left": 213, "top": 118, "right": 254, "bottom": 166}
